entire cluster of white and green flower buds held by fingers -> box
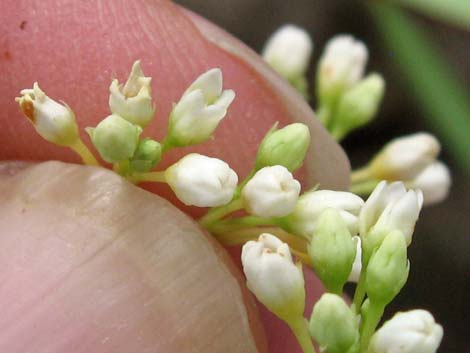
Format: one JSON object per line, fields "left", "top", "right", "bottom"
{"left": 17, "top": 34, "right": 448, "bottom": 353}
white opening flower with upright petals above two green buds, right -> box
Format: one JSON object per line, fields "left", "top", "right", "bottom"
{"left": 359, "top": 181, "right": 423, "bottom": 245}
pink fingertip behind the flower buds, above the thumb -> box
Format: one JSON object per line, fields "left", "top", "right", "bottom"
{"left": 0, "top": 0, "right": 349, "bottom": 353}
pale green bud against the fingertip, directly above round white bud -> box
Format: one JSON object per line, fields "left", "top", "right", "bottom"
{"left": 255, "top": 123, "right": 310, "bottom": 172}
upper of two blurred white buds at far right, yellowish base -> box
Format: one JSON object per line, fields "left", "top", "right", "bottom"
{"left": 369, "top": 132, "right": 441, "bottom": 181}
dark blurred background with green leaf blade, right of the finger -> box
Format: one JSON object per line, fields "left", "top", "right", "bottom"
{"left": 176, "top": 0, "right": 470, "bottom": 353}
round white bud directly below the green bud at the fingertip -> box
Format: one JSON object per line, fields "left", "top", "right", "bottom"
{"left": 242, "top": 165, "right": 300, "bottom": 217}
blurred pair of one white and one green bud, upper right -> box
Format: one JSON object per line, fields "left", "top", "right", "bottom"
{"left": 317, "top": 35, "right": 385, "bottom": 140}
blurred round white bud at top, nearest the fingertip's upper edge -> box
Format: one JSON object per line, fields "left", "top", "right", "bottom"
{"left": 263, "top": 25, "right": 313, "bottom": 80}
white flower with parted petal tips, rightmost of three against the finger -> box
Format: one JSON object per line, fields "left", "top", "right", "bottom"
{"left": 168, "top": 69, "right": 235, "bottom": 146}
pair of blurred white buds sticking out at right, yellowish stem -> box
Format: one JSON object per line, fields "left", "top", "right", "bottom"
{"left": 353, "top": 132, "right": 451, "bottom": 205}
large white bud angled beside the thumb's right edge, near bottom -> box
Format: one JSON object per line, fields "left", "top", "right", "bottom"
{"left": 241, "top": 233, "right": 305, "bottom": 322}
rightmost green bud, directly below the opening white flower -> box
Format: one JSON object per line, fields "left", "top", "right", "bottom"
{"left": 366, "top": 230, "right": 409, "bottom": 305}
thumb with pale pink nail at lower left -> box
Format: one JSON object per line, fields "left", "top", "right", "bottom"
{"left": 0, "top": 162, "right": 265, "bottom": 353}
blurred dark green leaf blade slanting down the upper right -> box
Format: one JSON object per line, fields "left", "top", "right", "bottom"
{"left": 369, "top": 2, "right": 470, "bottom": 173}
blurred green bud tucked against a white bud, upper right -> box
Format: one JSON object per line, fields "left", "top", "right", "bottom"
{"left": 334, "top": 73, "right": 385, "bottom": 135}
